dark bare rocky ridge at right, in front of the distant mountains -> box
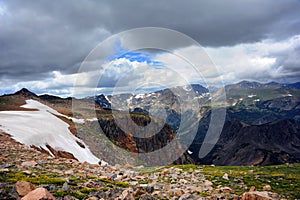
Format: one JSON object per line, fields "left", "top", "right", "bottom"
{"left": 193, "top": 120, "right": 300, "bottom": 165}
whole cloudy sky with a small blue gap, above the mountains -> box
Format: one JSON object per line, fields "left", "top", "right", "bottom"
{"left": 0, "top": 0, "right": 300, "bottom": 97}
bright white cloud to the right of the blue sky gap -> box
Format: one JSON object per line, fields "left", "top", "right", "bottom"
{"left": 150, "top": 36, "right": 300, "bottom": 86}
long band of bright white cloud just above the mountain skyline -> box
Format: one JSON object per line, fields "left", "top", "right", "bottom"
{"left": 0, "top": 36, "right": 300, "bottom": 97}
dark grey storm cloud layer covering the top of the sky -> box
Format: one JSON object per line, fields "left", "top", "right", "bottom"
{"left": 0, "top": 0, "right": 300, "bottom": 94}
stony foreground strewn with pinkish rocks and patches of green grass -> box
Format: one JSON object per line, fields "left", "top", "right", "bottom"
{"left": 0, "top": 132, "right": 299, "bottom": 200}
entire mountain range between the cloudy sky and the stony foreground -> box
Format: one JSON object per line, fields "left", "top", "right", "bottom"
{"left": 0, "top": 81, "right": 300, "bottom": 165}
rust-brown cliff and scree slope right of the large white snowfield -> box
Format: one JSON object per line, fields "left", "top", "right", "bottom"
{"left": 77, "top": 114, "right": 194, "bottom": 165}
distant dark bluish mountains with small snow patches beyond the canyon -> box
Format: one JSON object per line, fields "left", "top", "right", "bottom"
{"left": 91, "top": 81, "right": 300, "bottom": 165}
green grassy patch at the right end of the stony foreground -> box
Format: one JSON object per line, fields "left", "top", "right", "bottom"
{"left": 202, "top": 164, "right": 300, "bottom": 199}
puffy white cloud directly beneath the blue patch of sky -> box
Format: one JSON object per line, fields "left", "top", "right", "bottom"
{"left": 99, "top": 58, "right": 189, "bottom": 93}
